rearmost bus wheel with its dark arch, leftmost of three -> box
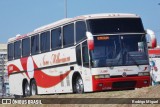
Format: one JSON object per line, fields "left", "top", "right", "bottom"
{"left": 22, "top": 79, "right": 30, "bottom": 97}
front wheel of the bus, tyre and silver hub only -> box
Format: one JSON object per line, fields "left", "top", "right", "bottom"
{"left": 75, "top": 77, "right": 84, "bottom": 93}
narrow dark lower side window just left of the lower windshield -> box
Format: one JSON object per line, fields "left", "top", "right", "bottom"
{"left": 82, "top": 42, "right": 89, "bottom": 67}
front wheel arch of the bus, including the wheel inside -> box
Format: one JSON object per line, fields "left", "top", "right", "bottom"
{"left": 72, "top": 72, "right": 84, "bottom": 93}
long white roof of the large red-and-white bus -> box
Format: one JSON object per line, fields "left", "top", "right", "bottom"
{"left": 8, "top": 13, "right": 139, "bottom": 42}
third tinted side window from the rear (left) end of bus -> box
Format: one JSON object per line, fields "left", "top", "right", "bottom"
{"left": 22, "top": 38, "right": 30, "bottom": 57}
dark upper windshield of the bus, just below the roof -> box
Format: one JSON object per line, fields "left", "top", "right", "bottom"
{"left": 88, "top": 18, "right": 144, "bottom": 35}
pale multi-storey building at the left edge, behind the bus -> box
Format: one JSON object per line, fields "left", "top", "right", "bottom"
{"left": 0, "top": 43, "right": 8, "bottom": 96}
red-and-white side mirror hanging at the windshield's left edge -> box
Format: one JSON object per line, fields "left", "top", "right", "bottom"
{"left": 86, "top": 32, "right": 94, "bottom": 50}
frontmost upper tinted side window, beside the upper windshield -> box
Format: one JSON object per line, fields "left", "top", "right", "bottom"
{"left": 76, "top": 21, "right": 86, "bottom": 42}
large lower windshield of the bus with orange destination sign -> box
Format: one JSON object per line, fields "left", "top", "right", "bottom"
{"left": 90, "top": 34, "right": 148, "bottom": 67}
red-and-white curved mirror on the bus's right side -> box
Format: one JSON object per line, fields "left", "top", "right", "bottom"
{"left": 146, "top": 29, "right": 157, "bottom": 48}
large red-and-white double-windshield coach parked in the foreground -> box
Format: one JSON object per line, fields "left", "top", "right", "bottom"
{"left": 7, "top": 13, "right": 150, "bottom": 96}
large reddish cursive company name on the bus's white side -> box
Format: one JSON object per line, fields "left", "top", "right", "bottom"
{"left": 43, "top": 53, "right": 70, "bottom": 66}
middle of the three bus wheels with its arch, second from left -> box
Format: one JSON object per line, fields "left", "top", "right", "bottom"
{"left": 30, "top": 78, "right": 38, "bottom": 95}
